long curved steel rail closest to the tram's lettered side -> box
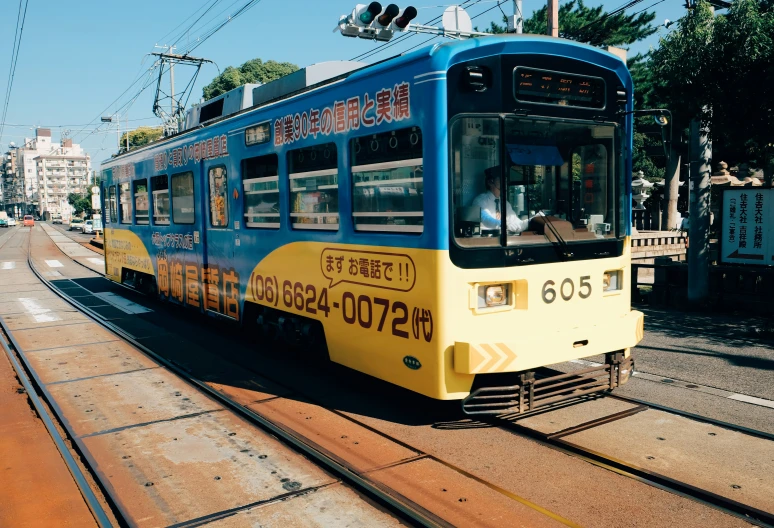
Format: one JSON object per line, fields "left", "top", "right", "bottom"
{"left": 25, "top": 226, "right": 453, "bottom": 528}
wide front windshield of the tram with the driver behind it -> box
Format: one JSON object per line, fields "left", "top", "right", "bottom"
{"left": 451, "top": 116, "right": 624, "bottom": 248}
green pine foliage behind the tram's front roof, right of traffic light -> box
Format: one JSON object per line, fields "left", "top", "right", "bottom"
{"left": 487, "top": 0, "right": 658, "bottom": 46}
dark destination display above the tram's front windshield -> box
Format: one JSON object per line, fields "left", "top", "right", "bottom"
{"left": 513, "top": 66, "right": 605, "bottom": 109}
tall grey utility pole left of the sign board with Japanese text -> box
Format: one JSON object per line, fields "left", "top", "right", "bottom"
{"left": 688, "top": 119, "right": 712, "bottom": 303}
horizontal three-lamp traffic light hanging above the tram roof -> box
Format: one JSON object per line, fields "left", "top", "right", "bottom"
{"left": 339, "top": 2, "right": 417, "bottom": 41}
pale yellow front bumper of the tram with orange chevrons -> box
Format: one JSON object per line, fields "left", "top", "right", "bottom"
{"left": 454, "top": 311, "right": 644, "bottom": 374}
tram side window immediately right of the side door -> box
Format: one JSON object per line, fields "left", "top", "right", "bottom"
{"left": 242, "top": 154, "right": 280, "bottom": 229}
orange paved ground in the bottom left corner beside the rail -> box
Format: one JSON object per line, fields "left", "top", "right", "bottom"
{"left": 0, "top": 344, "right": 97, "bottom": 528}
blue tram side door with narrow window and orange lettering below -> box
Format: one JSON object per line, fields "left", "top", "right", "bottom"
{"left": 199, "top": 160, "right": 240, "bottom": 320}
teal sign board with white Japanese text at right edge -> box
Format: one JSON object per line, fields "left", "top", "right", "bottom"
{"left": 720, "top": 187, "right": 774, "bottom": 266}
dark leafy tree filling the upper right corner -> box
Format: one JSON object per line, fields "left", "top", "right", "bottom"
{"left": 649, "top": 0, "right": 774, "bottom": 179}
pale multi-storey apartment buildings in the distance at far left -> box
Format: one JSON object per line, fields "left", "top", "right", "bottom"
{"left": 5, "top": 128, "right": 91, "bottom": 218}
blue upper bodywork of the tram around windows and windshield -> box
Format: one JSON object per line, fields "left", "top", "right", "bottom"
{"left": 103, "top": 35, "right": 632, "bottom": 262}
